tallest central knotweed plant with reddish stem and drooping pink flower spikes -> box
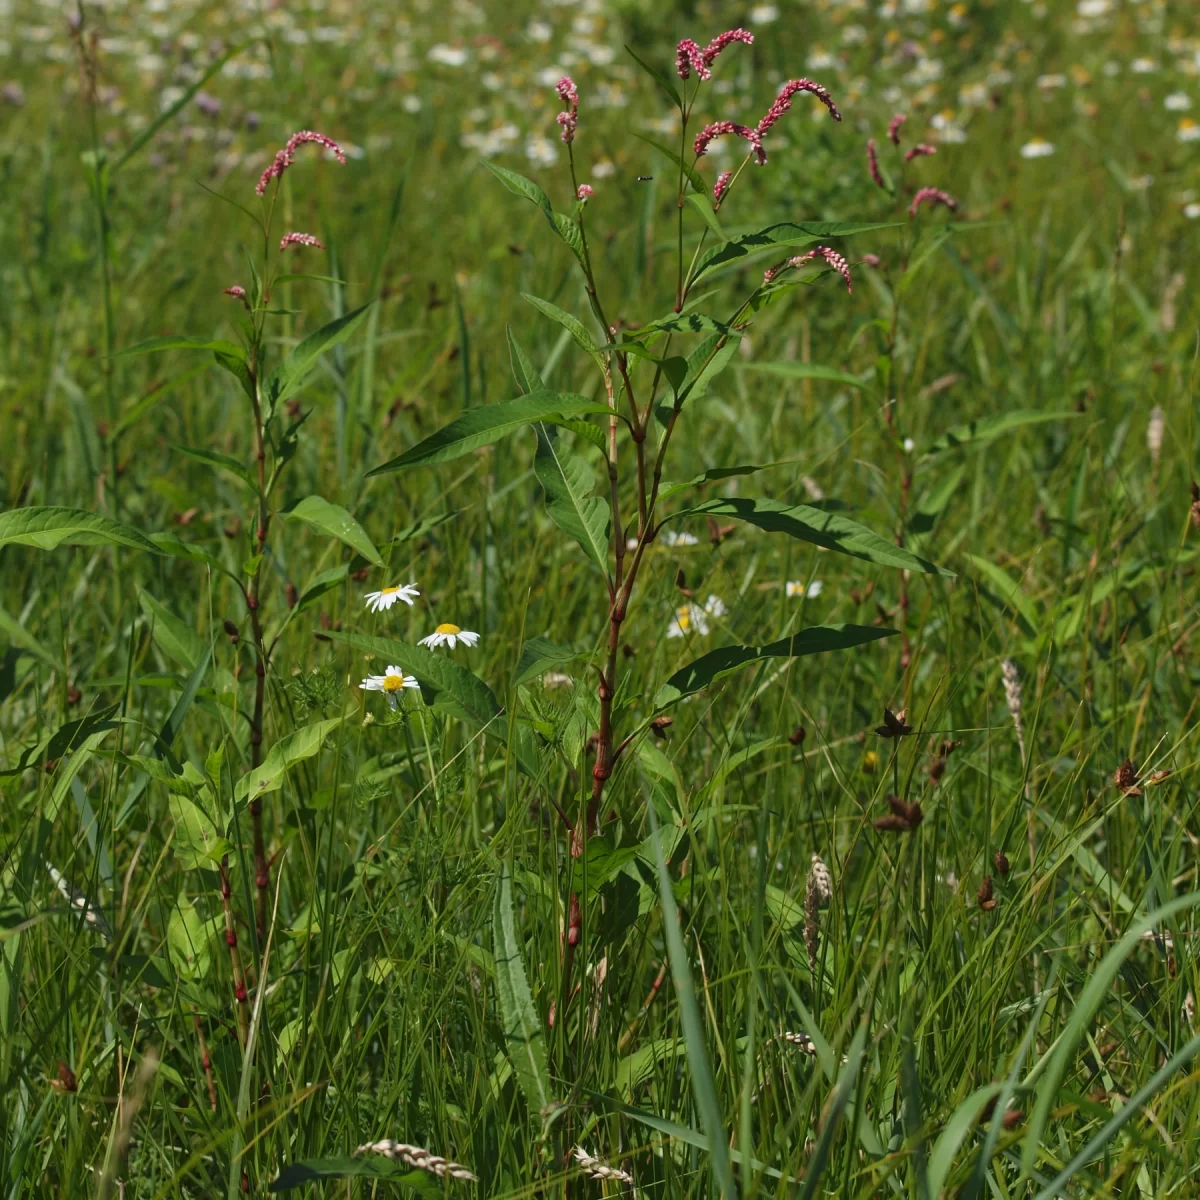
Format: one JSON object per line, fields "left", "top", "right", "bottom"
{"left": 360, "top": 29, "right": 938, "bottom": 1032}
